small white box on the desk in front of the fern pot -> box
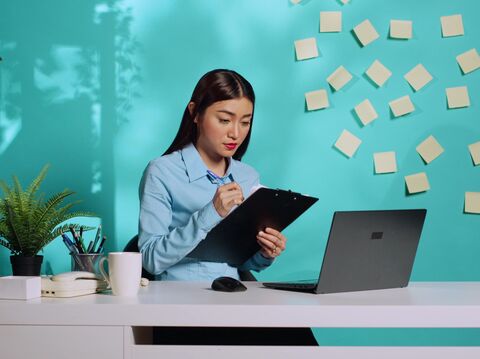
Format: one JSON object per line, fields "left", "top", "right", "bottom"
{"left": 0, "top": 276, "right": 41, "bottom": 300}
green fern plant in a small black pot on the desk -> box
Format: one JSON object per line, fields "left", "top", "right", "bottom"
{"left": 0, "top": 165, "right": 92, "bottom": 275}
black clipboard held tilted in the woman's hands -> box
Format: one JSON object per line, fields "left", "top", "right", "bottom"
{"left": 187, "top": 188, "right": 318, "bottom": 266}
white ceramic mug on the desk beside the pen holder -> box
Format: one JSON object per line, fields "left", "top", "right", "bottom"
{"left": 99, "top": 252, "right": 142, "bottom": 297}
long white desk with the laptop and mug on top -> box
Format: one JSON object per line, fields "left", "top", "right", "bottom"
{"left": 0, "top": 282, "right": 480, "bottom": 359}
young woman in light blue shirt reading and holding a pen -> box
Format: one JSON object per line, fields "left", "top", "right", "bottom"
{"left": 138, "top": 70, "right": 286, "bottom": 280}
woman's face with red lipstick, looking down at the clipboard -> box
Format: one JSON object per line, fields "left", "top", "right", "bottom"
{"left": 191, "top": 97, "right": 253, "bottom": 159}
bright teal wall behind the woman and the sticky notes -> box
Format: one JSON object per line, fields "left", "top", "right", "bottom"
{"left": 0, "top": 0, "right": 480, "bottom": 345}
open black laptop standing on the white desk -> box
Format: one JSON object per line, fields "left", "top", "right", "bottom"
{"left": 263, "top": 209, "right": 427, "bottom": 293}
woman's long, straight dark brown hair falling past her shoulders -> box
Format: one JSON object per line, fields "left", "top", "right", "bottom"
{"left": 163, "top": 69, "right": 255, "bottom": 161}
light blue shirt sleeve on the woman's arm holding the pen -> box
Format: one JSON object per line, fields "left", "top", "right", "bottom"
{"left": 138, "top": 164, "right": 222, "bottom": 275}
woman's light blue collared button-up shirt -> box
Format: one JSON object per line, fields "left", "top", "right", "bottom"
{"left": 138, "top": 144, "right": 273, "bottom": 281}
